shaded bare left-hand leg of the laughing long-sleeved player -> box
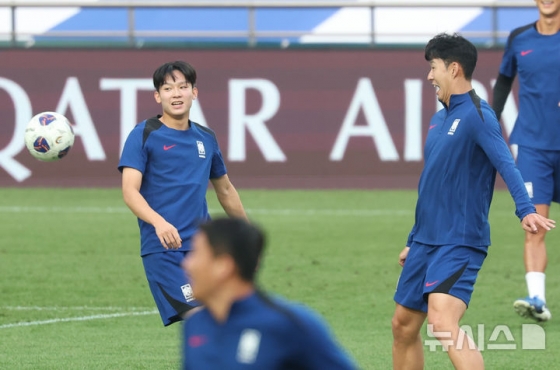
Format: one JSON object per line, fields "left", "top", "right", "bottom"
{"left": 392, "top": 303, "right": 426, "bottom": 370}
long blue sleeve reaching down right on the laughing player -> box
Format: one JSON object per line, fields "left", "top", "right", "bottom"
{"left": 473, "top": 110, "right": 536, "bottom": 220}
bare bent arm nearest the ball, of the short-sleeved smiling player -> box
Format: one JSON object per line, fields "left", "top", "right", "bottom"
{"left": 122, "top": 167, "right": 182, "bottom": 249}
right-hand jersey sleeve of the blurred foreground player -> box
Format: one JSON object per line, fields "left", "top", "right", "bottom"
{"left": 295, "top": 306, "right": 358, "bottom": 370}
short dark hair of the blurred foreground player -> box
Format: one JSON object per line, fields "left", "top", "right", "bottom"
{"left": 200, "top": 217, "right": 265, "bottom": 282}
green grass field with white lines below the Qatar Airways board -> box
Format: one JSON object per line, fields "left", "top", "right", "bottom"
{"left": 0, "top": 188, "right": 560, "bottom": 370}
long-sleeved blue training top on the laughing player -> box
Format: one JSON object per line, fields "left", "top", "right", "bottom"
{"left": 407, "top": 90, "right": 535, "bottom": 247}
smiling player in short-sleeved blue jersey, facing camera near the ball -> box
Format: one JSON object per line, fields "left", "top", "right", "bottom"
{"left": 118, "top": 61, "right": 246, "bottom": 326}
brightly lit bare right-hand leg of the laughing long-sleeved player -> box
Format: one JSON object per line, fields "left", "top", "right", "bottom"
{"left": 428, "top": 293, "right": 484, "bottom": 370}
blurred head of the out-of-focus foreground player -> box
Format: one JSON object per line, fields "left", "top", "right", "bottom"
{"left": 183, "top": 218, "right": 265, "bottom": 302}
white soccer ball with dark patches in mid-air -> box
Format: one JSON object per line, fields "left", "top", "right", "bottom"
{"left": 25, "top": 112, "right": 74, "bottom": 162}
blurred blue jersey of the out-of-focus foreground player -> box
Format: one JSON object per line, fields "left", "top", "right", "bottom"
{"left": 182, "top": 293, "right": 357, "bottom": 370}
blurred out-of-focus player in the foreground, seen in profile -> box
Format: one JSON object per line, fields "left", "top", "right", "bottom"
{"left": 183, "top": 218, "right": 356, "bottom": 370}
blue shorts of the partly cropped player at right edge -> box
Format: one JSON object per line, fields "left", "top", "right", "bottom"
{"left": 517, "top": 146, "right": 560, "bottom": 205}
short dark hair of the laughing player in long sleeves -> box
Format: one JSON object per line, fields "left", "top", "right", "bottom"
{"left": 424, "top": 33, "right": 478, "bottom": 80}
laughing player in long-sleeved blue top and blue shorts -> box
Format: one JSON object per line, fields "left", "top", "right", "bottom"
{"left": 392, "top": 34, "right": 554, "bottom": 370}
